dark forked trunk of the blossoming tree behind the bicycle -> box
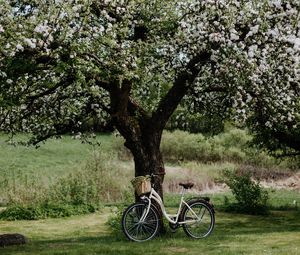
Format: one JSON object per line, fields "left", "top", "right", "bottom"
{"left": 103, "top": 52, "right": 211, "bottom": 237}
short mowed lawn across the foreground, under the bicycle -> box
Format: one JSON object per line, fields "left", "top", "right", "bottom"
{"left": 0, "top": 208, "right": 300, "bottom": 255}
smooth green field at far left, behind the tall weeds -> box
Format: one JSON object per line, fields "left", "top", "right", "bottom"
{"left": 0, "top": 134, "right": 112, "bottom": 177}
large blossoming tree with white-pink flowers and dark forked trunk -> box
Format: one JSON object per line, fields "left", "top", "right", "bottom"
{"left": 0, "top": 0, "right": 300, "bottom": 195}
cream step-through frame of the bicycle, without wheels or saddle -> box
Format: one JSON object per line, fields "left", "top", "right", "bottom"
{"left": 140, "top": 187, "right": 203, "bottom": 224}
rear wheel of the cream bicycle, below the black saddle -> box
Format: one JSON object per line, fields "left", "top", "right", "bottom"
{"left": 182, "top": 201, "right": 215, "bottom": 239}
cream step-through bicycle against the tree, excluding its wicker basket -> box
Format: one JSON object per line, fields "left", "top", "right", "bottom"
{"left": 121, "top": 174, "right": 215, "bottom": 242}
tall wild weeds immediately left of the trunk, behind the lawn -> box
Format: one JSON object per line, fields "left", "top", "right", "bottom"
{"left": 50, "top": 151, "right": 131, "bottom": 205}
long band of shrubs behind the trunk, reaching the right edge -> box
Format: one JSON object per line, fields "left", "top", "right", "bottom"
{"left": 112, "top": 127, "right": 299, "bottom": 169}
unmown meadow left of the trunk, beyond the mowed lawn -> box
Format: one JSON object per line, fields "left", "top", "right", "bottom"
{"left": 0, "top": 134, "right": 133, "bottom": 206}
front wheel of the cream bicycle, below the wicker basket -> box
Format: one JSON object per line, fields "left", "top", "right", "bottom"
{"left": 122, "top": 203, "right": 159, "bottom": 242}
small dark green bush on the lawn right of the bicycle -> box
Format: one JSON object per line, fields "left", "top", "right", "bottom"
{"left": 223, "top": 170, "right": 269, "bottom": 214}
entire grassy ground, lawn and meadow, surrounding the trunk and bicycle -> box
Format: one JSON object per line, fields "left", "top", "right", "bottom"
{"left": 0, "top": 129, "right": 300, "bottom": 255}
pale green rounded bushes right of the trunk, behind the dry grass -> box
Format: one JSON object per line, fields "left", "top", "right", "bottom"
{"left": 161, "top": 129, "right": 250, "bottom": 162}
